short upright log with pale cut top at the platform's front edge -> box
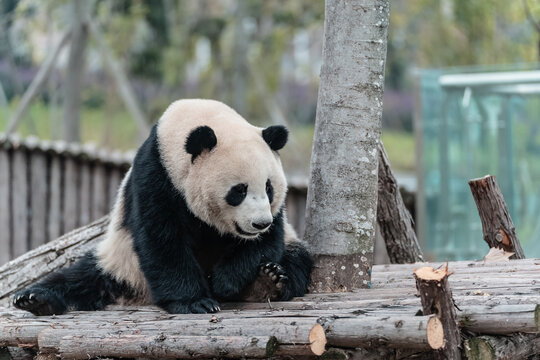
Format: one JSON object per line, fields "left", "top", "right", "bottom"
{"left": 414, "top": 267, "right": 461, "bottom": 360}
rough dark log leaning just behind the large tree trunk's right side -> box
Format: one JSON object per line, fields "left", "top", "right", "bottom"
{"left": 377, "top": 142, "right": 424, "bottom": 264}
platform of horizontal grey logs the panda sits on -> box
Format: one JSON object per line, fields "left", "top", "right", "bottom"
{"left": 0, "top": 259, "right": 540, "bottom": 359}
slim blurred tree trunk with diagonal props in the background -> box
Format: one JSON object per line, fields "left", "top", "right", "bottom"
{"left": 64, "top": 0, "right": 92, "bottom": 142}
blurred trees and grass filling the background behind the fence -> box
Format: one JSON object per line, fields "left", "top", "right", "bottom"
{"left": 0, "top": 0, "right": 540, "bottom": 175}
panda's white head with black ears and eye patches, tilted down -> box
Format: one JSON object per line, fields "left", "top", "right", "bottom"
{"left": 158, "top": 99, "right": 288, "bottom": 239}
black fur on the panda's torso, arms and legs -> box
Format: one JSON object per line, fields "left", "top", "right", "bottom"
{"left": 15, "top": 126, "right": 312, "bottom": 315}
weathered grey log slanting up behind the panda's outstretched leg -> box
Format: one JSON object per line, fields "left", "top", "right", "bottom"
{"left": 0, "top": 217, "right": 109, "bottom": 306}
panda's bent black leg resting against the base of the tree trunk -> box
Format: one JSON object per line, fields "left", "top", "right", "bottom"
{"left": 272, "top": 241, "right": 313, "bottom": 300}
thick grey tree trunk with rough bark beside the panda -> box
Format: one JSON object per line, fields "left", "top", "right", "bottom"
{"left": 304, "top": 0, "right": 390, "bottom": 292}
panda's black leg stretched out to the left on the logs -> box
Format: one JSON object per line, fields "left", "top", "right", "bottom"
{"left": 13, "top": 251, "right": 127, "bottom": 315}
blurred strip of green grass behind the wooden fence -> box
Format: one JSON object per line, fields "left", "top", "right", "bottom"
{"left": 0, "top": 102, "right": 415, "bottom": 174}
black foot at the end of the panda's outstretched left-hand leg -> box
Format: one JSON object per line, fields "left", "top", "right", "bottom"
{"left": 13, "top": 288, "right": 66, "bottom": 316}
